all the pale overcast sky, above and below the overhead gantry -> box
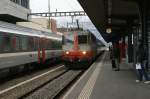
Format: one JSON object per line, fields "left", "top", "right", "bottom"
{"left": 30, "top": 0, "right": 104, "bottom": 44}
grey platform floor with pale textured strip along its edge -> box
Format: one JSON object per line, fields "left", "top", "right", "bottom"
{"left": 63, "top": 52, "right": 150, "bottom": 99}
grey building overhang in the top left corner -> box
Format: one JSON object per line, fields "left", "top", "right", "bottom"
{"left": 0, "top": 0, "right": 30, "bottom": 23}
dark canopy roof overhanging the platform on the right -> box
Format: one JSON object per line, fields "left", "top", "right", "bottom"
{"left": 78, "top": 0, "right": 139, "bottom": 42}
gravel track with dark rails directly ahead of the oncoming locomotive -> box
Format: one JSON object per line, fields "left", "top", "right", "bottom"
{"left": 21, "top": 70, "right": 83, "bottom": 99}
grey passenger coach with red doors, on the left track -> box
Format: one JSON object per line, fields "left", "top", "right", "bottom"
{"left": 0, "top": 22, "right": 62, "bottom": 70}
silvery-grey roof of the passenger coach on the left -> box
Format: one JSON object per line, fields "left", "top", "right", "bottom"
{"left": 0, "top": 21, "right": 62, "bottom": 40}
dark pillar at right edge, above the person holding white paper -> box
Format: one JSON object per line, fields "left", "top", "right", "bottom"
{"left": 139, "top": 0, "right": 150, "bottom": 71}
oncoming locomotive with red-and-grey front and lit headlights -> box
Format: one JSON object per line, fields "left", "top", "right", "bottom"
{"left": 63, "top": 30, "right": 97, "bottom": 68}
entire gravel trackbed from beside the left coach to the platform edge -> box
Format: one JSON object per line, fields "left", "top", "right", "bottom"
{"left": 0, "top": 65, "right": 83, "bottom": 99}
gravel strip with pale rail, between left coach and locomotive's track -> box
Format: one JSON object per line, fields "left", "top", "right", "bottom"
{"left": 0, "top": 65, "right": 67, "bottom": 99}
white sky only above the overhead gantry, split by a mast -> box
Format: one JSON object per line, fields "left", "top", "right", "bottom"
{"left": 30, "top": 0, "right": 83, "bottom": 12}
